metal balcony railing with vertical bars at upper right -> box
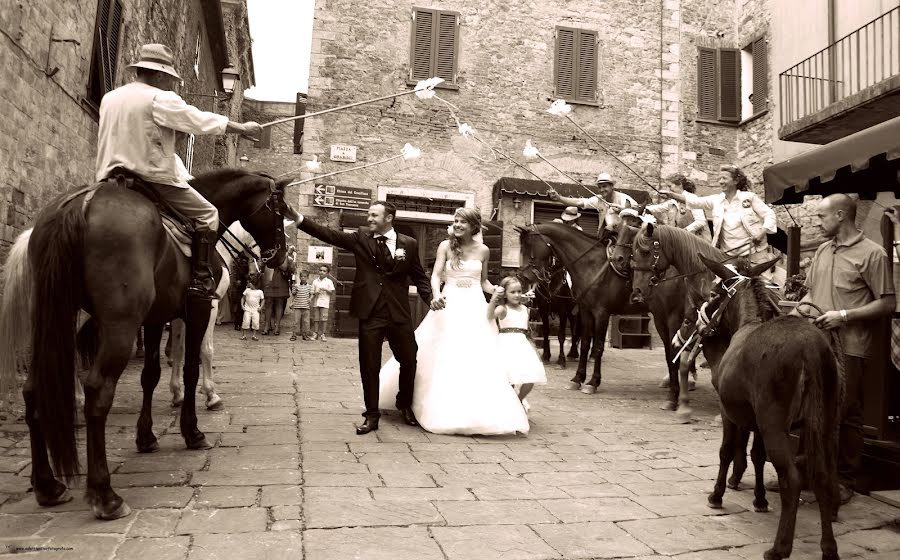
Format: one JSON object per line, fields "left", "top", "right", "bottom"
{"left": 779, "top": 6, "right": 900, "bottom": 125}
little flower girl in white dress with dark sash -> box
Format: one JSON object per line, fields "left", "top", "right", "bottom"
{"left": 488, "top": 276, "right": 547, "bottom": 411}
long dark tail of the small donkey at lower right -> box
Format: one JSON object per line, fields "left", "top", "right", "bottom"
{"left": 801, "top": 332, "right": 844, "bottom": 494}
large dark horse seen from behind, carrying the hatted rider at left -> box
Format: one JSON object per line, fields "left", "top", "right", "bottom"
{"left": 0, "top": 170, "right": 296, "bottom": 519}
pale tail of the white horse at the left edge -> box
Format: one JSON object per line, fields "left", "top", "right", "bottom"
{"left": 0, "top": 229, "right": 32, "bottom": 395}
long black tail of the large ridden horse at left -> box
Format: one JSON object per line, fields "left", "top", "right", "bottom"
{"left": 28, "top": 199, "right": 87, "bottom": 479}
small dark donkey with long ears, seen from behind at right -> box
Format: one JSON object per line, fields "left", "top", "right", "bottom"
{"left": 701, "top": 257, "right": 843, "bottom": 560}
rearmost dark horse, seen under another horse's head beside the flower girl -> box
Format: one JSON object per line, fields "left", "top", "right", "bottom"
{"left": 534, "top": 258, "right": 583, "bottom": 369}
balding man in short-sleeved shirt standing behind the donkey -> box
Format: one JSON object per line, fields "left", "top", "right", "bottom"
{"left": 803, "top": 194, "right": 895, "bottom": 503}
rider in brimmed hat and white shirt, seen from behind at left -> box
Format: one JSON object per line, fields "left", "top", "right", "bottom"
{"left": 96, "top": 44, "right": 262, "bottom": 299}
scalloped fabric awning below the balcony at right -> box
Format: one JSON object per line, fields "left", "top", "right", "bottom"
{"left": 763, "top": 117, "right": 900, "bottom": 204}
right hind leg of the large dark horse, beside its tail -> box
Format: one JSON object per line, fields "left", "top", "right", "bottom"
{"left": 84, "top": 328, "right": 136, "bottom": 519}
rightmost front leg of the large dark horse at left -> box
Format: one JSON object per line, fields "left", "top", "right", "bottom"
{"left": 179, "top": 297, "right": 212, "bottom": 449}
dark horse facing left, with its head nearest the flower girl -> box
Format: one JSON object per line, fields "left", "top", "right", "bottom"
{"left": 517, "top": 223, "right": 685, "bottom": 398}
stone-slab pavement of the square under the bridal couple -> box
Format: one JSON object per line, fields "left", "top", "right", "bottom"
{"left": 0, "top": 326, "right": 900, "bottom": 560}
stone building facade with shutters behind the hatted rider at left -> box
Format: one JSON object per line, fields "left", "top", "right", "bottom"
{"left": 0, "top": 0, "right": 253, "bottom": 262}
